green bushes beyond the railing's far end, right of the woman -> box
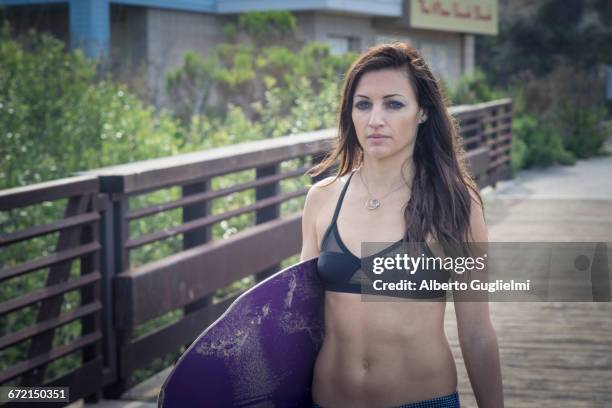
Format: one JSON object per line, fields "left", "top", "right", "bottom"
{"left": 445, "top": 67, "right": 609, "bottom": 172}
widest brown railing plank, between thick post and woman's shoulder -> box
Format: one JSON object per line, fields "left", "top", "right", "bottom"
{"left": 115, "top": 214, "right": 301, "bottom": 327}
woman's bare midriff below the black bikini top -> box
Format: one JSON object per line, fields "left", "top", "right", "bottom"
{"left": 312, "top": 292, "right": 457, "bottom": 407}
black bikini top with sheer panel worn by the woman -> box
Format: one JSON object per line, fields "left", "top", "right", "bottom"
{"left": 317, "top": 173, "right": 450, "bottom": 299}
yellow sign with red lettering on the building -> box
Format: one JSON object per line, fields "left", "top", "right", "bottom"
{"left": 409, "top": 0, "right": 497, "bottom": 34}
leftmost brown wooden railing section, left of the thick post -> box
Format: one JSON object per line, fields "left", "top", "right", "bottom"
{"left": 0, "top": 176, "right": 104, "bottom": 402}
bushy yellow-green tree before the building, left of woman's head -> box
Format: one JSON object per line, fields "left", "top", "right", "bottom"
{"left": 167, "top": 12, "right": 356, "bottom": 126}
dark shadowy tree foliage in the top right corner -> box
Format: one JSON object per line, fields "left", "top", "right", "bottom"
{"left": 476, "top": 0, "right": 612, "bottom": 85}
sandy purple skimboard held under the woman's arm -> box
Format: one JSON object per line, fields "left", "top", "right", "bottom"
{"left": 158, "top": 259, "right": 324, "bottom": 408}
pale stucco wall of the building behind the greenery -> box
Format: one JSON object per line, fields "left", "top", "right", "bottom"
{"left": 113, "top": 8, "right": 474, "bottom": 106}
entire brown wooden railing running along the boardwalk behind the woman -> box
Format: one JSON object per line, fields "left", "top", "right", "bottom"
{"left": 0, "top": 100, "right": 512, "bottom": 400}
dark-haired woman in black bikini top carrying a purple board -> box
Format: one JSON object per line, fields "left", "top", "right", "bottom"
{"left": 301, "top": 43, "right": 503, "bottom": 408}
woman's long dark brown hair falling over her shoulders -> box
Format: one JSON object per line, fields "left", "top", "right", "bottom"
{"left": 309, "top": 42, "right": 482, "bottom": 248}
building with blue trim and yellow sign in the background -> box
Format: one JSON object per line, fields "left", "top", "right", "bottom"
{"left": 0, "top": 0, "right": 498, "bottom": 101}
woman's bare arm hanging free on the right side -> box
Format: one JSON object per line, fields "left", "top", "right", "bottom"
{"left": 455, "top": 195, "right": 504, "bottom": 408}
